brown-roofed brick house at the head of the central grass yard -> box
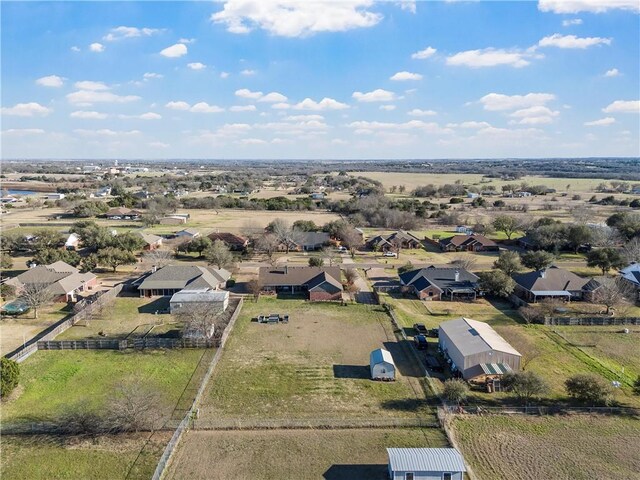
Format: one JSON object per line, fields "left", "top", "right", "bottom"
{"left": 259, "top": 266, "right": 342, "bottom": 301}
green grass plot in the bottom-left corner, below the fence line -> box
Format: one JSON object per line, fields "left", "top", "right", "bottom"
{"left": 0, "top": 432, "right": 171, "bottom": 480}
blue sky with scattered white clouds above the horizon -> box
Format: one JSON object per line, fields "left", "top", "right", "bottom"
{"left": 1, "top": 0, "right": 640, "bottom": 159}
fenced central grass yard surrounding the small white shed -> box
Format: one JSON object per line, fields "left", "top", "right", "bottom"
{"left": 200, "top": 298, "right": 426, "bottom": 424}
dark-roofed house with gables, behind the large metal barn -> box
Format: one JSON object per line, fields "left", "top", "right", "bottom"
{"left": 400, "top": 265, "right": 482, "bottom": 300}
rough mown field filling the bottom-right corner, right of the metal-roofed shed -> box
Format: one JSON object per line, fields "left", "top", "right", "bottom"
{"left": 452, "top": 415, "right": 640, "bottom": 480}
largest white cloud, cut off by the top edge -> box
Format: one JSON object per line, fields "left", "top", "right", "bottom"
{"left": 211, "top": 0, "right": 382, "bottom": 37}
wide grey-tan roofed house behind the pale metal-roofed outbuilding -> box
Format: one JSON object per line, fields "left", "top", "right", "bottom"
{"left": 136, "top": 265, "right": 231, "bottom": 297}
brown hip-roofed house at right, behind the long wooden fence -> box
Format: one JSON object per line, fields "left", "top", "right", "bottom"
{"left": 512, "top": 265, "right": 600, "bottom": 303}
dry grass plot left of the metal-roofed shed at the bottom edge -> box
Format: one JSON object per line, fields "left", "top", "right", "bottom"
{"left": 167, "top": 428, "right": 447, "bottom": 480}
